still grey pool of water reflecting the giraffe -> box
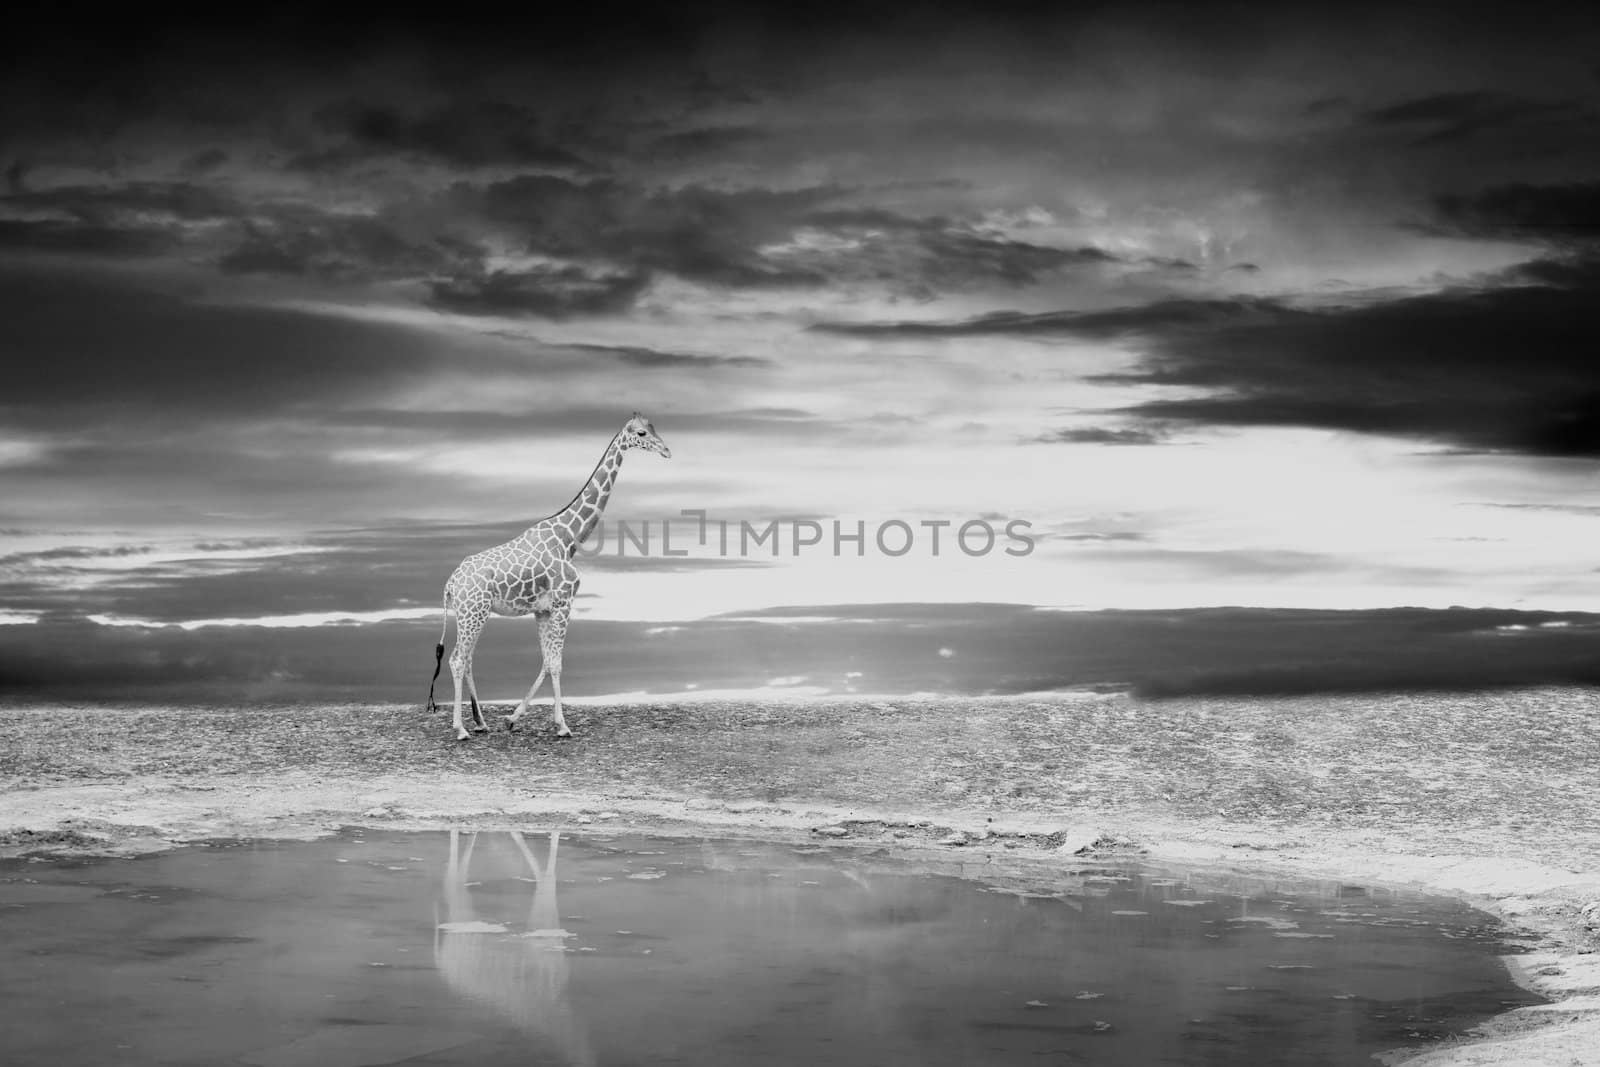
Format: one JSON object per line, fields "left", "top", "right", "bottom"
{"left": 0, "top": 832, "right": 1536, "bottom": 1067}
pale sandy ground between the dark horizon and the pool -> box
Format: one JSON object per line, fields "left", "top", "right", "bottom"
{"left": 0, "top": 689, "right": 1600, "bottom": 1067}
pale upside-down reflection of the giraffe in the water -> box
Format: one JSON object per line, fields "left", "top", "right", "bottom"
{"left": 434, "top": 830, "right": 595, "bottom": 1067}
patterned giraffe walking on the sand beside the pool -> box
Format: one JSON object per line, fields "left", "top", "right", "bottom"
{"left": 427, "top": 411, "right": 672, "bottom": 741}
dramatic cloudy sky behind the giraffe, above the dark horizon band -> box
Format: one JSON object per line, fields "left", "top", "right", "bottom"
{"left": 0, "top": 2, "right": 1600, "bottom": 691}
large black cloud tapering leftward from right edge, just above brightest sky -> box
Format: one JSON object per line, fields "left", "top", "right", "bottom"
{"left": 821, "top": 264, "right": 1600, "bottom": 458}
